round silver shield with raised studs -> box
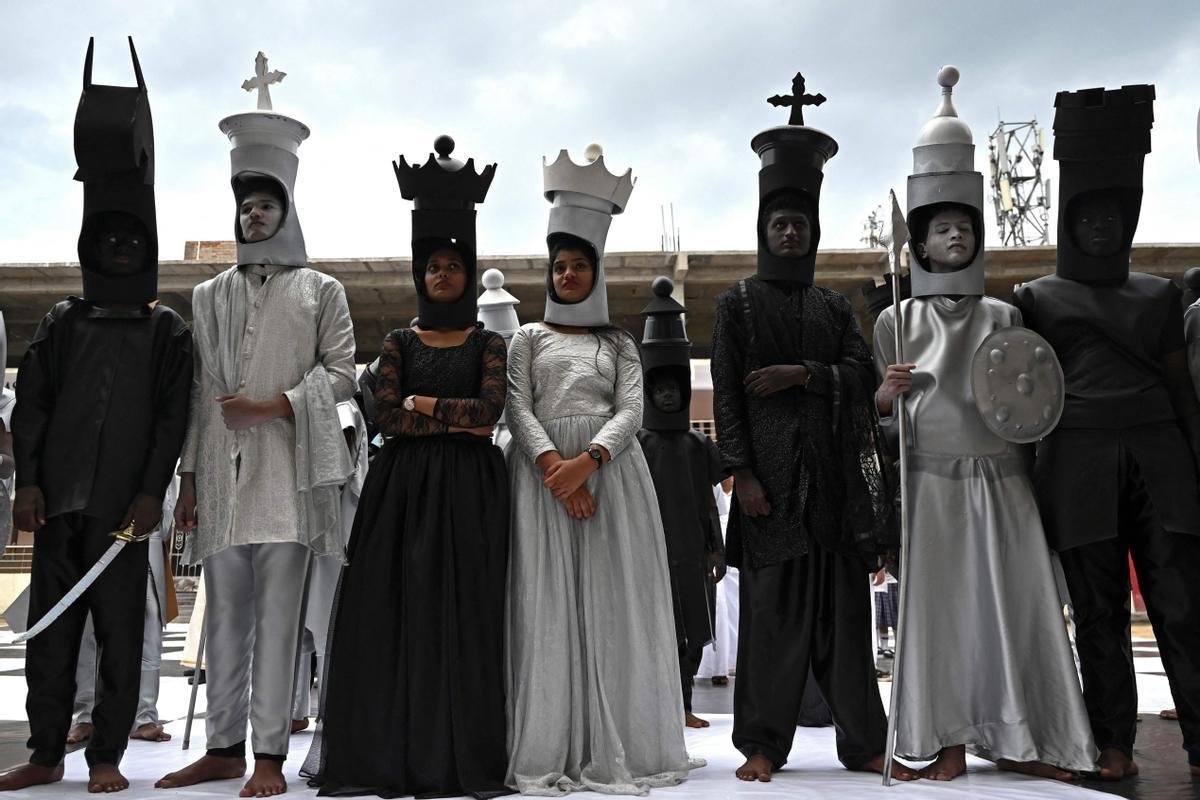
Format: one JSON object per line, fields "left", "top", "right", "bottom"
{"left": 971, "top": 327, "right": 1064, "bottom": 444}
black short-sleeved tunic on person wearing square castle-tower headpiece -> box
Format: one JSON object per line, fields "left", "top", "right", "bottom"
{"left": 1015, "top": 272, "right": 1200, "bottom": 551}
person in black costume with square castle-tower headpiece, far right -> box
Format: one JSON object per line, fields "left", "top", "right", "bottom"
{"left": 1015, "top": 85, "right": 1200, "bottom": 780}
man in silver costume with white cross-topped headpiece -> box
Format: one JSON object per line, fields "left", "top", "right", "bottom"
{"left": 156, "top": 54, "right": 355, "bottom": 796}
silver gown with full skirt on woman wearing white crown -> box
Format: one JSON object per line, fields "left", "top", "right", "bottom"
{"left": 505, "top": 323, "right": 698, "bottom": 795}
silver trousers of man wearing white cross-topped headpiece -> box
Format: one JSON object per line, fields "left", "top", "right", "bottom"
{"left": 204, "top": 542, "right": 310, "bottom": 756}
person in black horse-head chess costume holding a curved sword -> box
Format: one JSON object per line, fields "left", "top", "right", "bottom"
{"left": 0, "top": 40, "right": 192, "bottom": 792}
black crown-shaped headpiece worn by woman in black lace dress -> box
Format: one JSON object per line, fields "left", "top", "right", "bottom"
{"left": 392, "top": 136, "right": 496, "bottom": 329}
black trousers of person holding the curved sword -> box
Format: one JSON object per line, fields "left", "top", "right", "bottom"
{"left": 25, "top": 513, "right": 149, "bottom": 766}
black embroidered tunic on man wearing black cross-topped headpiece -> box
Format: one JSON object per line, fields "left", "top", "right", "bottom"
{"left": 712, "top": 278, "right": 875, "bottom": 567}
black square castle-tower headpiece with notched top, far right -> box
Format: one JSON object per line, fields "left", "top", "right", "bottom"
{"left": 1054, "top": 84, "right": 1154, "bottom": 283}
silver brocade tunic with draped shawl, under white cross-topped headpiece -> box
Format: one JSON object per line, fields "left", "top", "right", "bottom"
{"left": 179, "top": 267, "right": 355, "bottom": 564}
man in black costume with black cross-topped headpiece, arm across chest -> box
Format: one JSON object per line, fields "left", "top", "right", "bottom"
{"left": 712, "top": 71, "right": 917, "bottom": 781}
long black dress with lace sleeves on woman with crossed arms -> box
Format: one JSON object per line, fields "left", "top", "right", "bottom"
{"left": 305, "top": 329, "right": 509, "bottom": 798}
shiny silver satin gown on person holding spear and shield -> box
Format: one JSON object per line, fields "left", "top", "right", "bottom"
{"left": 875, "top": 296, "right": 1097, "bottom": 770}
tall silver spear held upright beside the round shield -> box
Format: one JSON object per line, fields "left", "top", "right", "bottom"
{"left": 880, "top": 191, "right": 908, "bottom": 786}
